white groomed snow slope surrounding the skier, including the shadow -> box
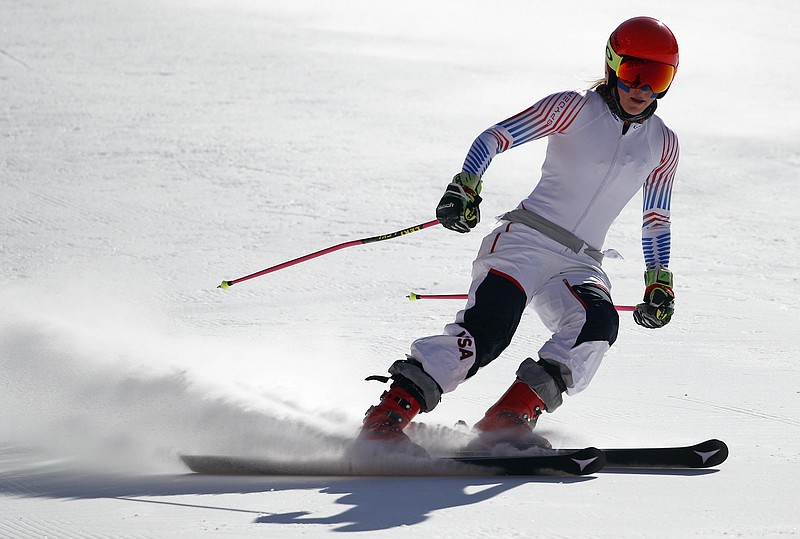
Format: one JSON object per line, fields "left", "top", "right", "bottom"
{"left": 0, "top": 0, "right": 800, "bottom": 538}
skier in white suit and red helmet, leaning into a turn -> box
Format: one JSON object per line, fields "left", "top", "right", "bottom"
{"left": 359, "top": 17, "right": 678, "bottom": 452}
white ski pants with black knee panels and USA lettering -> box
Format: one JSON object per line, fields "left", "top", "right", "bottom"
{"left": 411, "top": 222, "right": 618, "bottom": 402}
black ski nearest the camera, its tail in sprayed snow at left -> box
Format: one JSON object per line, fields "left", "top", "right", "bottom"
{"left": 181, "top": 447, "right": 605, "bottom": 476}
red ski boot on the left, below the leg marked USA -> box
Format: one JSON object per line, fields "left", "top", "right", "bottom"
{"left": 356, "top": 386, "right": 428, "bottom": 456}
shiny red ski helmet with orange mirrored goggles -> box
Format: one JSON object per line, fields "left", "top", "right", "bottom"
{"left": 606, "top": 17, "right": 678, "bottom": 97}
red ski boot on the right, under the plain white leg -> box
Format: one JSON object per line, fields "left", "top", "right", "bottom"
{"left": 470, "top": 380, "right": 550, "bottom": 449}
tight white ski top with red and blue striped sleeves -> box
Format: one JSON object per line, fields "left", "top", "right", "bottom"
{"left": 463, "top": 91, "right": 679, "bottom": 269}
